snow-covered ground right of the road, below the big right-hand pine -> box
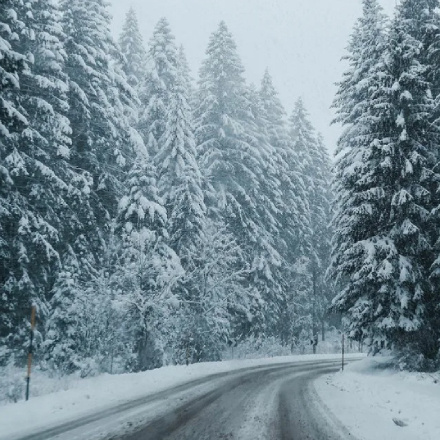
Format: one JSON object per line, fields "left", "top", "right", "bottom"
{"left": 314, "top": 357, "right": 440, "bottom": 440}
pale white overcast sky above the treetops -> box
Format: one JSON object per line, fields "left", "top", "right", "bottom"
{"left": 110, "top": 0, "right": 396, "bottom": 152}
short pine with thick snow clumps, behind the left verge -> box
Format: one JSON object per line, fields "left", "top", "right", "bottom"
{"left": 116, "top": 154, "right": 183, "bottom": 371}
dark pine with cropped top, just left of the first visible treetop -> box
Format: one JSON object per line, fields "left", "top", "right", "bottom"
{"left": 61, "top": 0, "right": 133, "bottom": 220}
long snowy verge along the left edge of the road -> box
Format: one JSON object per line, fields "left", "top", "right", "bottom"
{"left": 0, "top": 354, "right": 359, "bottom": 440}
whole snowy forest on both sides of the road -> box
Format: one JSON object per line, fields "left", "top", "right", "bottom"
{"left": 0, "top": 0, "right": 440, "bottom": 375}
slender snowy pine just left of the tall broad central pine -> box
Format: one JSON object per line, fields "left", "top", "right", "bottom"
{"left": 155, "top": 53, "right": 211, "bottom": 360}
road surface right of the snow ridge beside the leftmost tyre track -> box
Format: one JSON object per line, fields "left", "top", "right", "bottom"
{"left": 118, "top": 361, "right": 354, "bottom": 440}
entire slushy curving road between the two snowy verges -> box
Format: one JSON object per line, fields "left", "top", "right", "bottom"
{"left": 16, "top": 361, "right": 355, "bottom": 440}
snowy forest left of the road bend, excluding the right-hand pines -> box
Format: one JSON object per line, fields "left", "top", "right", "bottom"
{"left": 0, "top": 0, "right": 334, "bottom": 375}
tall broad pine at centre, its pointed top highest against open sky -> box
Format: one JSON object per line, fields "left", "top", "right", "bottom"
{"left": 195, "top": 22, "right": 278, "bottom": 340}
